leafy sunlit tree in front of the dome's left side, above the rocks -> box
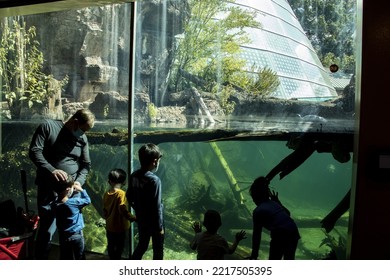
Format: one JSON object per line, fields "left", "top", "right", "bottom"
{"left": 172, "top": 0, "right": 277, "bottom": 99}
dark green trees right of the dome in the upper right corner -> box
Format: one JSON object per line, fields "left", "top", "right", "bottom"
{"left": 289, "top": 0, "right": 356, "bottom": 73}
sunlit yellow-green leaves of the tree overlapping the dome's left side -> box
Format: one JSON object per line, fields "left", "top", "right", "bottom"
{"left": 173, "top": 0, "right": 260, "bottom": 89}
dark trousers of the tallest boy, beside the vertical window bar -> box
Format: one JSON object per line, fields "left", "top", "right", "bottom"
{"left": 131, "top": 224, "right": 164, "bottom": 260}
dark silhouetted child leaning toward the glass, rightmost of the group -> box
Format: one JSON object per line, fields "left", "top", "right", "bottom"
{"left": 249, "top": 177, "right": 300, "bottom": 260}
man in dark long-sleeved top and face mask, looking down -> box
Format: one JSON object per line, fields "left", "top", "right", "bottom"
{"left": 29, "top": 109, "right": 95, "bottom": 259}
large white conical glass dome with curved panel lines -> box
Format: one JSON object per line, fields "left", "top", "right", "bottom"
{"left": 232, "top": 0, "right": 337, "bottom": 101}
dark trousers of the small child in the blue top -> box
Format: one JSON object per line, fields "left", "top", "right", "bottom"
{"left": 59, "top": 231, "right": 85, "bottom": 260}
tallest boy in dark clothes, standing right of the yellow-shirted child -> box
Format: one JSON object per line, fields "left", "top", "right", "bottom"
{"left": 126, "top": 143, "right": 164, "bottom": 260}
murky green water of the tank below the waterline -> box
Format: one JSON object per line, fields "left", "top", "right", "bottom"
{"left": 0, "top": 124, "right": 352, "bottom": 260}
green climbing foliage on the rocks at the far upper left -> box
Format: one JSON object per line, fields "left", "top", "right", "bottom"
{"left": 0, "top": 19, "right": 57, "bottom": 119}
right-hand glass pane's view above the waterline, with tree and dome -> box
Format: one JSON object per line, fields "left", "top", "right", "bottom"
{"left": 134, "top": 0, "right": 354, "bottom": 131}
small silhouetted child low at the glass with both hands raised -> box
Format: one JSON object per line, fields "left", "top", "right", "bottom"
{"left": 190, "top": 210, "right": 246, "bottom": 260}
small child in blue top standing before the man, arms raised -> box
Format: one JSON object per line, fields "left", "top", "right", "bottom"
{"left": 52, "top": 175, "right": 91, "bottom": 260}
